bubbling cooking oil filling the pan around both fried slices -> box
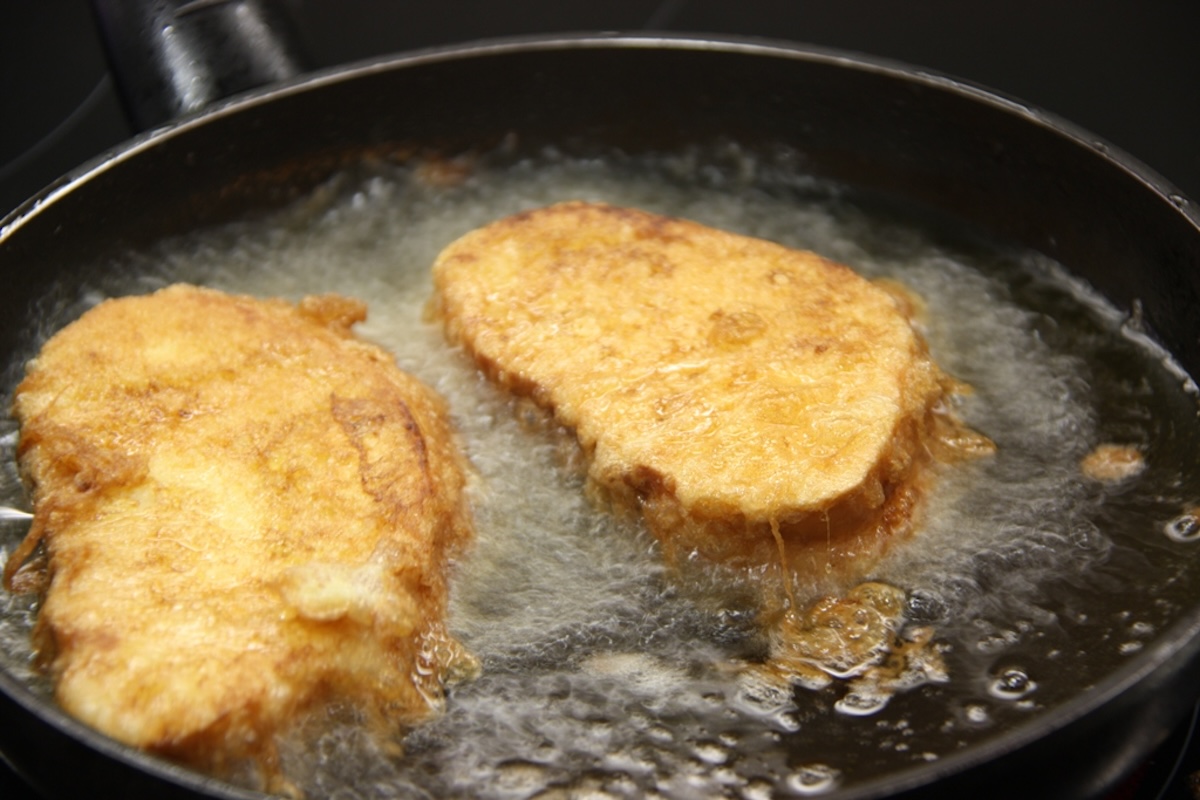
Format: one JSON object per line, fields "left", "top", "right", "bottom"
{"left": 0, "top": 148, "right": 1200, "bottom": 798}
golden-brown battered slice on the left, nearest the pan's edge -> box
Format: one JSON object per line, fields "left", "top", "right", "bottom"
{"left": 7, "top": 285, "right": 472, "bottom": 788}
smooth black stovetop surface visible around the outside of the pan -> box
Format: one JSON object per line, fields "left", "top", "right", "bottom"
{"left": 0, "top": 0, "right": 1200, "bottom": 800}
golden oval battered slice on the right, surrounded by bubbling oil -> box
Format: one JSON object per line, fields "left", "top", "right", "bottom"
{"left": 433, "top": 201, "right": 991, "bottom": 585}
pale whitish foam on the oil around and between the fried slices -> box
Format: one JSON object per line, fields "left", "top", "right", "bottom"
{"left": 0, "top": 146, "right": 1195, "bottom": 798}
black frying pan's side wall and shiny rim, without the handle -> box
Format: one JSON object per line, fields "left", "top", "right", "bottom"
{"left": 0, "top": 3, "right": 1200, "bottom": 800}
